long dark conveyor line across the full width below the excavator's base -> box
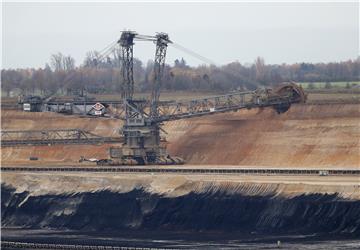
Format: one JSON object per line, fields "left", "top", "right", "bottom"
{"left": 1, "top": 166, "right": 360, "bottom": 176}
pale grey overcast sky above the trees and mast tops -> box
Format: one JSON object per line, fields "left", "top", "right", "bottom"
{"left": 2, "top": 2, "right": 359, "bottom": 68}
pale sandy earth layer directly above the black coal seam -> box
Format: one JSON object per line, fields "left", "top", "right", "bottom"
{"left": 2, "top": 172, "right": 360, "bottom": 199}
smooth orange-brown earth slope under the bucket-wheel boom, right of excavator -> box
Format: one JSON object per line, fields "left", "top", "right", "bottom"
{"left": 165, "top": 104, "right": 360, "bottom": 167}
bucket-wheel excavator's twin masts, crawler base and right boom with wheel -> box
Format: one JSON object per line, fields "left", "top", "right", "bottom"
{"left": 91, "top": 31, "right": 306, "bottom": 165}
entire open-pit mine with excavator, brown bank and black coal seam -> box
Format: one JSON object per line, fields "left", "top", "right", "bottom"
{"left": 1, "top": 29, "right": 360, "bottom": 249}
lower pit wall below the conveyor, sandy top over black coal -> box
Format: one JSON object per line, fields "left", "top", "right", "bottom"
{"left": 1, "top": 173, "right": 360, "bottom": 237}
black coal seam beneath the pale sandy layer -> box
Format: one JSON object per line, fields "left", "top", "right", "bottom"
{"left": 1, "top": 185, "right": 360, "bottom": 235}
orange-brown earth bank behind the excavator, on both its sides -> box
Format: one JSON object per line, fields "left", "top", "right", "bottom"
{"left": 1, "top": 104, "right": 360, "bottom": 168}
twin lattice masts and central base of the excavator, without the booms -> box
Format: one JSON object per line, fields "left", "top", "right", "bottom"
{"left": 119, "top": 31, "right": 182, "bottom": 164}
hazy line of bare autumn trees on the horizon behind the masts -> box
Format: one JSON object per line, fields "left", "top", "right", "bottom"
{"left": 1, "top": 51, "right": 360, "bottom": 95}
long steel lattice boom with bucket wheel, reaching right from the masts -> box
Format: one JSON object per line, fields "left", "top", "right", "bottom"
{"left": 112, "top": 82, "right": 306, "bottom": 123}
